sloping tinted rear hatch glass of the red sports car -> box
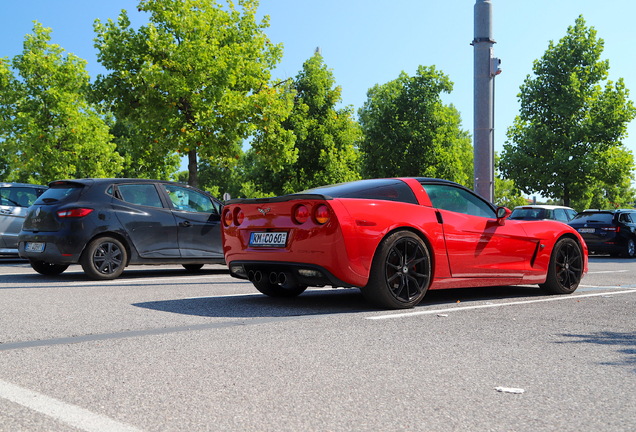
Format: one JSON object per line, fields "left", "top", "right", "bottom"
{"left": 301, "top": 179, "right": 418, "bottom": 204}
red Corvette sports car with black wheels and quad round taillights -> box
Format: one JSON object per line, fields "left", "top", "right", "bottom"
{"left": 223, "top": 178, "right": 587, "bottom": 309}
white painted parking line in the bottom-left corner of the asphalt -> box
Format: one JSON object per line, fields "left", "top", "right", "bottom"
{"left": 0, "top": 380, "right": 141, "bottom": 432}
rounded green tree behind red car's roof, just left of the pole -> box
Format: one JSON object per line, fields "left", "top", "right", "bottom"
{"left": 358, "top": 66, "right": 473, "bottom": 186}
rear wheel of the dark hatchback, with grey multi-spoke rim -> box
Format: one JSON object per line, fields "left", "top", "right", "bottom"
{"left": 80, "top": 237, "right": 128, "bottom": 279}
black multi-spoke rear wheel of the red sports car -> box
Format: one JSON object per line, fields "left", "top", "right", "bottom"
{"left": 362, "top": 231, "right": 431, "bottom": 309}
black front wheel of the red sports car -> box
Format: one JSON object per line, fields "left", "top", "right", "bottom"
{"left": 539, "top": 238, "right": 583, "bottom": 294}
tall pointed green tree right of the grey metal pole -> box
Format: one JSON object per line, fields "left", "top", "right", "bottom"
{"left": 501, "top": 16, "right": 636, "bottom": 206}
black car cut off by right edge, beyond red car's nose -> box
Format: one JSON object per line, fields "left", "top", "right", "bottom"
{"left": 569, "top": 209, "right": 636, "bottom": 258}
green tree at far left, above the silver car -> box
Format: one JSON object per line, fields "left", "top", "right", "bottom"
{"left": 0, "top": 22, "right": 121, "bottom": 183}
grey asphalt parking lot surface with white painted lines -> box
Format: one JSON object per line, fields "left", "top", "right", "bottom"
{"left": 0, "top": 257, "right": 636, "bottom": 431}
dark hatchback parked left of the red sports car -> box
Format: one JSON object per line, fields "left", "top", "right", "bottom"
{"left": 18, "top": 179, "right": 225, "bottom": 279}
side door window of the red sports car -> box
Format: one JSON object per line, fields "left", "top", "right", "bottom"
{"left": 422, "top": 184, "right": 496, "bottom": 218}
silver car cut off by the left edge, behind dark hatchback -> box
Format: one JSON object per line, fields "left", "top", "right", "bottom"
{"left": 0, "top": 183, "right": 47, "bottom": 256}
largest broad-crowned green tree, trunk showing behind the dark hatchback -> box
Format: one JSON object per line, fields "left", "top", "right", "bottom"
{"left": 95, "top": 0, "right": 294, "bottom": 186}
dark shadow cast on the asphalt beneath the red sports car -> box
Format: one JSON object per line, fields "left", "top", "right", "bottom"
{"left": 133, "top": 286, "right": 545, "bottom": 318}
